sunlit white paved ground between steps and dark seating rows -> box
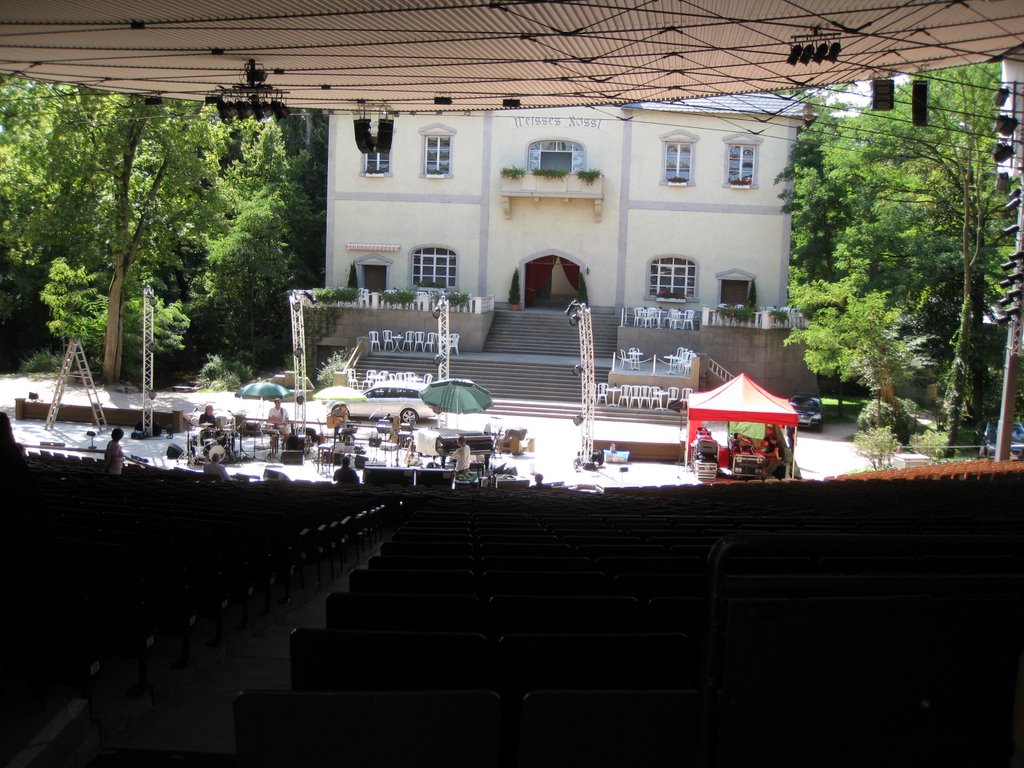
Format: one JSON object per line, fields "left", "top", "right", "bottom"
{"left": 0, "top": 376, "right": 867, "bottom": 486}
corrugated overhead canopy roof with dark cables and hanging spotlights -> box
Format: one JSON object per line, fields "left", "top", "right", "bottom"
{"left": 0, "top": 0, "right": 1024, "bottom": 113}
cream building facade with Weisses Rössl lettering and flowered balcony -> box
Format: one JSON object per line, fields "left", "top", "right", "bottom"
{"left": 326, "top": 94, "right": 803, "bottom": 311}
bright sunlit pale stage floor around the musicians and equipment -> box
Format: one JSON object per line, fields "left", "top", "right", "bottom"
{"left": 0, "top": 376, "right": 866, "bottom": 488}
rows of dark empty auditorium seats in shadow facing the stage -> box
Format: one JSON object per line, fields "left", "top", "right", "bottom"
{"left": 8, "top": 450, "right": 1024, "bottom": 768}
